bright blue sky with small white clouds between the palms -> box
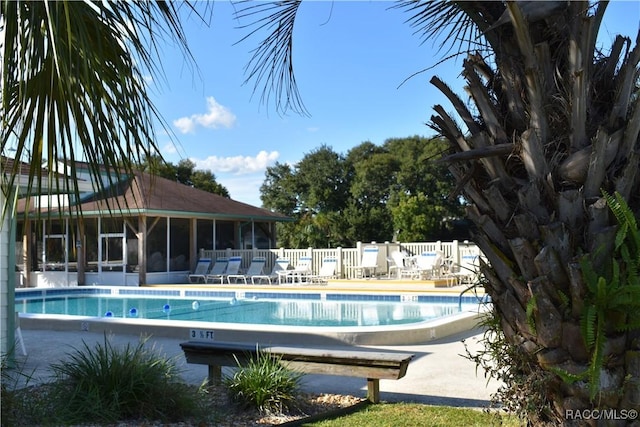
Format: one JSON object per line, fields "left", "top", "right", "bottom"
{"left": 152, "top": 1, "right": 640, "bottom": 206}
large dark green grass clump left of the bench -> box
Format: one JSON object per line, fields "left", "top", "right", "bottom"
{"left": 50, "top": 335, "right": 201, "bottom": 424}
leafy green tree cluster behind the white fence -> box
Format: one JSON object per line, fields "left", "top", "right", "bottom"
{"left": 260, "top": 136, "right": 469, "bottom": 247}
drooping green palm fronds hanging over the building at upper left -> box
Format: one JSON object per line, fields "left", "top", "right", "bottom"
{"left": 0, "top": 0, "right": 198, "bottom": 353}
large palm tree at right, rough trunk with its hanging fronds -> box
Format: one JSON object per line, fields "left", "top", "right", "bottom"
{"left": 239, "top": 0, "right": 640, "bottom": 424}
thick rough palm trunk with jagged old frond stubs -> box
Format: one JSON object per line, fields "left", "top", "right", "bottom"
{"left": 430, "top": 2, "right": 640, "bottom": 423}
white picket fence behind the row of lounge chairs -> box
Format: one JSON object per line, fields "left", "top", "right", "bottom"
{"left": 199, "top": 240, "right": 481, "bottom": 278}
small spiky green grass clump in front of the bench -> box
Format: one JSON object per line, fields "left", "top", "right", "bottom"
{"left": 223, "top": 351, "right": 302, "bottom": 414}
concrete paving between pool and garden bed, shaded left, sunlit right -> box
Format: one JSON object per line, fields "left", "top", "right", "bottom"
{"left": 11, "top": 329, "right": 498, "bottom": 407}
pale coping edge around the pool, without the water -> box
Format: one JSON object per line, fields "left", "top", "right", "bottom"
{"left": 16, "top": 286, "right": 484, "bottom": 346}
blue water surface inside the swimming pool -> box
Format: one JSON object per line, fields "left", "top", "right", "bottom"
{"left": 16, "top": 288, "right": 479, "bottom": 327}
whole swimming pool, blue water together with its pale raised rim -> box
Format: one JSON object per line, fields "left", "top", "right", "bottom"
{"left": 15, "top": 287, "right": 488, "bottom": 344}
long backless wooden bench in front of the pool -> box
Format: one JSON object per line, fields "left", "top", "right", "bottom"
{"left": 180, "top": 341, "right": 413, "bottom": 403}
